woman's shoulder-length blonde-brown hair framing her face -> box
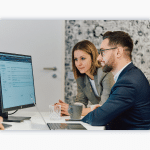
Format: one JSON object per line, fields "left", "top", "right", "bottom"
{"left": 72, "top": 40, "right": 101, "bottom": 79}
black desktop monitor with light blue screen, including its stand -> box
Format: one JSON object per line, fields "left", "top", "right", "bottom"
{"left": 0, "top": 52, "right": 36, "bottom": 122}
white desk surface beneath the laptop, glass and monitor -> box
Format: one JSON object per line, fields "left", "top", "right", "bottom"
{"left": 4, "top": 110, "right": 104, "bottom": 130}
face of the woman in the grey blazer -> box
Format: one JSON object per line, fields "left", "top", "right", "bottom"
{"left": 74, "top": 50, "right": 92, "bottom": 75}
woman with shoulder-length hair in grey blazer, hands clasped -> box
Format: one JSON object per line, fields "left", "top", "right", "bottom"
{"left": 57, "top": 40, "right": 114, "bottom": 116}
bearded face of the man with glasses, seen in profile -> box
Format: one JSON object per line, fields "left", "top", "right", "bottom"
{"left": 97, "top": 39, "right": 116, "bottom": 72}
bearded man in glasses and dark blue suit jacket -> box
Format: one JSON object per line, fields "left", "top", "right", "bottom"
{"left": 82, "top": 31, "right": 150, "bottom": 130}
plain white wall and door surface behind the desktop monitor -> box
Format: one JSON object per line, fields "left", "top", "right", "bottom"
{"left": 0, "top": 20, "right": 65, "bottom": 111}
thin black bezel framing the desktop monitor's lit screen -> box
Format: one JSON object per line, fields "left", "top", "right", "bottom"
{"left": 0, "top": 52, "right": 36, "bottom": 113}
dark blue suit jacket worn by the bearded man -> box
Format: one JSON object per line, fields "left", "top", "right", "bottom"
{"left": 82, "top": 63, "right": 150, "bottom": 130}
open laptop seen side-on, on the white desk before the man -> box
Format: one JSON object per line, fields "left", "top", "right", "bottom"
{"left": 31, "top": 98, "right": 87, "bottom": 130}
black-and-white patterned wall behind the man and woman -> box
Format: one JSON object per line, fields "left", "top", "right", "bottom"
{"left": 65, "top": 20, "right": 150, "bottom": 103}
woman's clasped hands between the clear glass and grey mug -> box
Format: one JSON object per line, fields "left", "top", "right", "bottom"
{"left": 55, "top": 100, "right": 69, "bottom": 116}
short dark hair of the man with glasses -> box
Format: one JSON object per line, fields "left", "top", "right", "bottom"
{"left": 103, "top": 31, "right": 133, "bottom": 59}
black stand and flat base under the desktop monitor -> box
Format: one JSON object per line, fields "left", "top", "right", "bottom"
{"left": 2, "top": 112, "right": 31, "bottom": 122}
